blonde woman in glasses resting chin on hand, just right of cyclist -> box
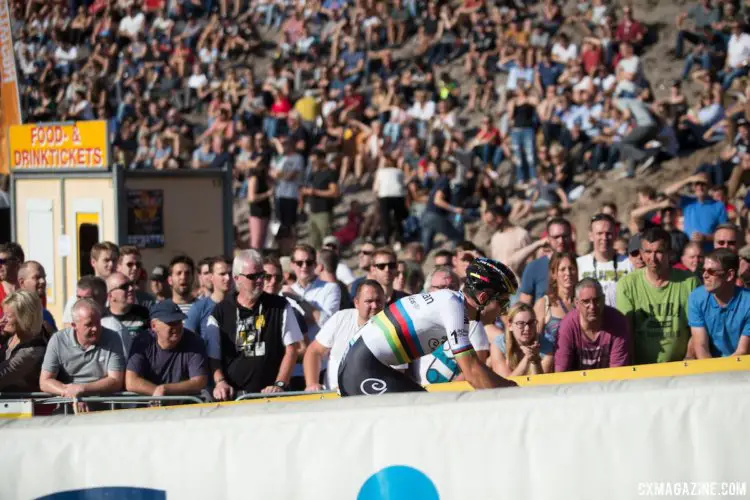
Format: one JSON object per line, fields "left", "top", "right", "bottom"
{"left": 490, "top": 302, "right": 544, "bottom": 377}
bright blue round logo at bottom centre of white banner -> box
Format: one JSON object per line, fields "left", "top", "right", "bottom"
{"left": 357, "top": 465, "right": 440, "bottom": 500}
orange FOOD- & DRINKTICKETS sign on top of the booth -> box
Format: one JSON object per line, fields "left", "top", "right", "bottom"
{"left": 8, "top": 120, "right": 109, "bottom": 169}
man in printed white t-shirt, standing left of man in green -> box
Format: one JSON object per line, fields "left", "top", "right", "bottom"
{"left": 577, "top": 214, "right": 633, "bottom": 307}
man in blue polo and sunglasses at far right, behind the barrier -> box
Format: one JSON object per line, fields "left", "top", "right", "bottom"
{"left": 688, "top": 248, "right": 750, "bottom": 359}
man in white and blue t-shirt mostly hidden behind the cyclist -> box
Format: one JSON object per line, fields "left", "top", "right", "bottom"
{"left": 414, "top": 266, "right": 490, "bottom": 385}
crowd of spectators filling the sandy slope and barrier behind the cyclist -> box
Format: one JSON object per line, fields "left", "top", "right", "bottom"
{"left": 0, "top": 0, "right": 750, "bottom": 406}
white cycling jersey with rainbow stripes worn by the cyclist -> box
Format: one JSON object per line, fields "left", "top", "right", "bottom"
{"left": 357, "top": 290, "right": 474, "bottom": 365}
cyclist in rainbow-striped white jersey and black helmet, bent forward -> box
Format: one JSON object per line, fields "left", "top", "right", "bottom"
{"left": 339, "top": 258, "right": 518, "bottom": 396}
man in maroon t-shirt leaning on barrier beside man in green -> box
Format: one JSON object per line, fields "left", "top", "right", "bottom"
{"left": 554, "top": 278, "right": 633, "bottom": 372}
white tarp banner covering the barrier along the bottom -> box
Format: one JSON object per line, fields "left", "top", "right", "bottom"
{"left": 0, "top": 373, "right": 750, "bottom": 500}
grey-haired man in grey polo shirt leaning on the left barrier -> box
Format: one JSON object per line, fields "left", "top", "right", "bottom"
{"left": 39, "top": 299, "right": 125, "bottom": 411}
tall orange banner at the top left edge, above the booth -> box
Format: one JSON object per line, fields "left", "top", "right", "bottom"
{"left": 0, "top": 0, "right": 21, "bottom": 174}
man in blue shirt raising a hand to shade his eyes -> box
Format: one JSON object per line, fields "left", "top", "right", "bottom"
{"left": 664, "top": 173, "right": 727, "bottom": 251}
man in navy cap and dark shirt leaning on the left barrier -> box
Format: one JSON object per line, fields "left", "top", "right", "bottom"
{"left": 125, "top": 300, "right": 208, "bottom": 396}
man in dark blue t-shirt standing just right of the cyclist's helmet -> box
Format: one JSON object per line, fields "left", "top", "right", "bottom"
{"left": 519, "top": 217, "right": 573, "bottom": 305}
